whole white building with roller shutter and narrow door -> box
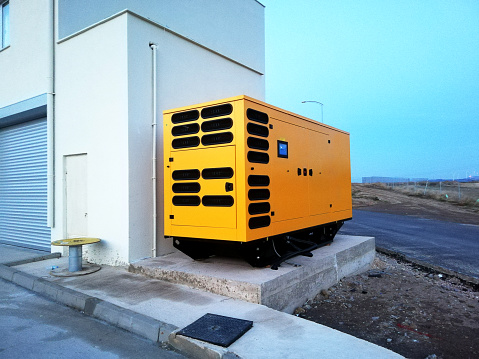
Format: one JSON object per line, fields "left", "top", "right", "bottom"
{"left": 0, "top": 0, "right": 264, "bottom": 265}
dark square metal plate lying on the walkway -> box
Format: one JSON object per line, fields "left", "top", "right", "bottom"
{"left": 177, "top": 313, "right": 253, "bottom": 347}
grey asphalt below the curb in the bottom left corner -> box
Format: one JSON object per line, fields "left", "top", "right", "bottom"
{"left": 0, "top": 279, "right": 185, "bottom": 359}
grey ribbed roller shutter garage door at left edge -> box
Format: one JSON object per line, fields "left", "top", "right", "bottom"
{"left": 0, "top": 118, "right": 50, "bottom": 252}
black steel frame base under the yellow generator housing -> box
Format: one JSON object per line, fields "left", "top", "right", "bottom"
{"left": 173, "top": 218, "right": 350, "bottom": 270}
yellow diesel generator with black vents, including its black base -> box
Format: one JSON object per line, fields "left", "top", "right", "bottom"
{"left": 163, "top": 96, "right": 352, "bottom": 269}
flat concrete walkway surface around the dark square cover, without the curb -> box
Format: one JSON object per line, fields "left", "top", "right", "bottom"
{"left": 11, "top": 258, "right": 402, "bottom": 359}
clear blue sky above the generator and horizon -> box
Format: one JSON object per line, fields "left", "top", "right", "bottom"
{"left": 260, "top": 0, "right": 479, "bottom": 182}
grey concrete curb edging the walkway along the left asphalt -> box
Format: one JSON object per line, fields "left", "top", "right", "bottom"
{"left": 0, "top": 257, "right": 236, "bottom": 359}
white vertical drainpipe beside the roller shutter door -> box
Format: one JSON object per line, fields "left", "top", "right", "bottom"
{"left": 47, "top": 0, "right": 55, "bottom": 228}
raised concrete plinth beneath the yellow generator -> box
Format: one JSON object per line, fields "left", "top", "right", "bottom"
{"left": 129, "top": 235, "right": 375, "bottom": 313}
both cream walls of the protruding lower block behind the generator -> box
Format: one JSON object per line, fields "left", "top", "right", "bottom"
{"left": 52, "top": 11, "right": 264, "bottom": 265}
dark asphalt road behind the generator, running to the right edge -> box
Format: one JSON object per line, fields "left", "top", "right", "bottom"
{"left": 339, "top": 210, "right": 479, "bottom": 278}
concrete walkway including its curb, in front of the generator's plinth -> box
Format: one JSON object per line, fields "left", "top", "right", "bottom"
{"left": 0, "top": 245, "right": 402, "bottom": 359}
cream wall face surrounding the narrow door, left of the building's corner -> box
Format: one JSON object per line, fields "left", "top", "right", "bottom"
{"left": 52, "top": 15, "right": 129, "bottom": 265}
